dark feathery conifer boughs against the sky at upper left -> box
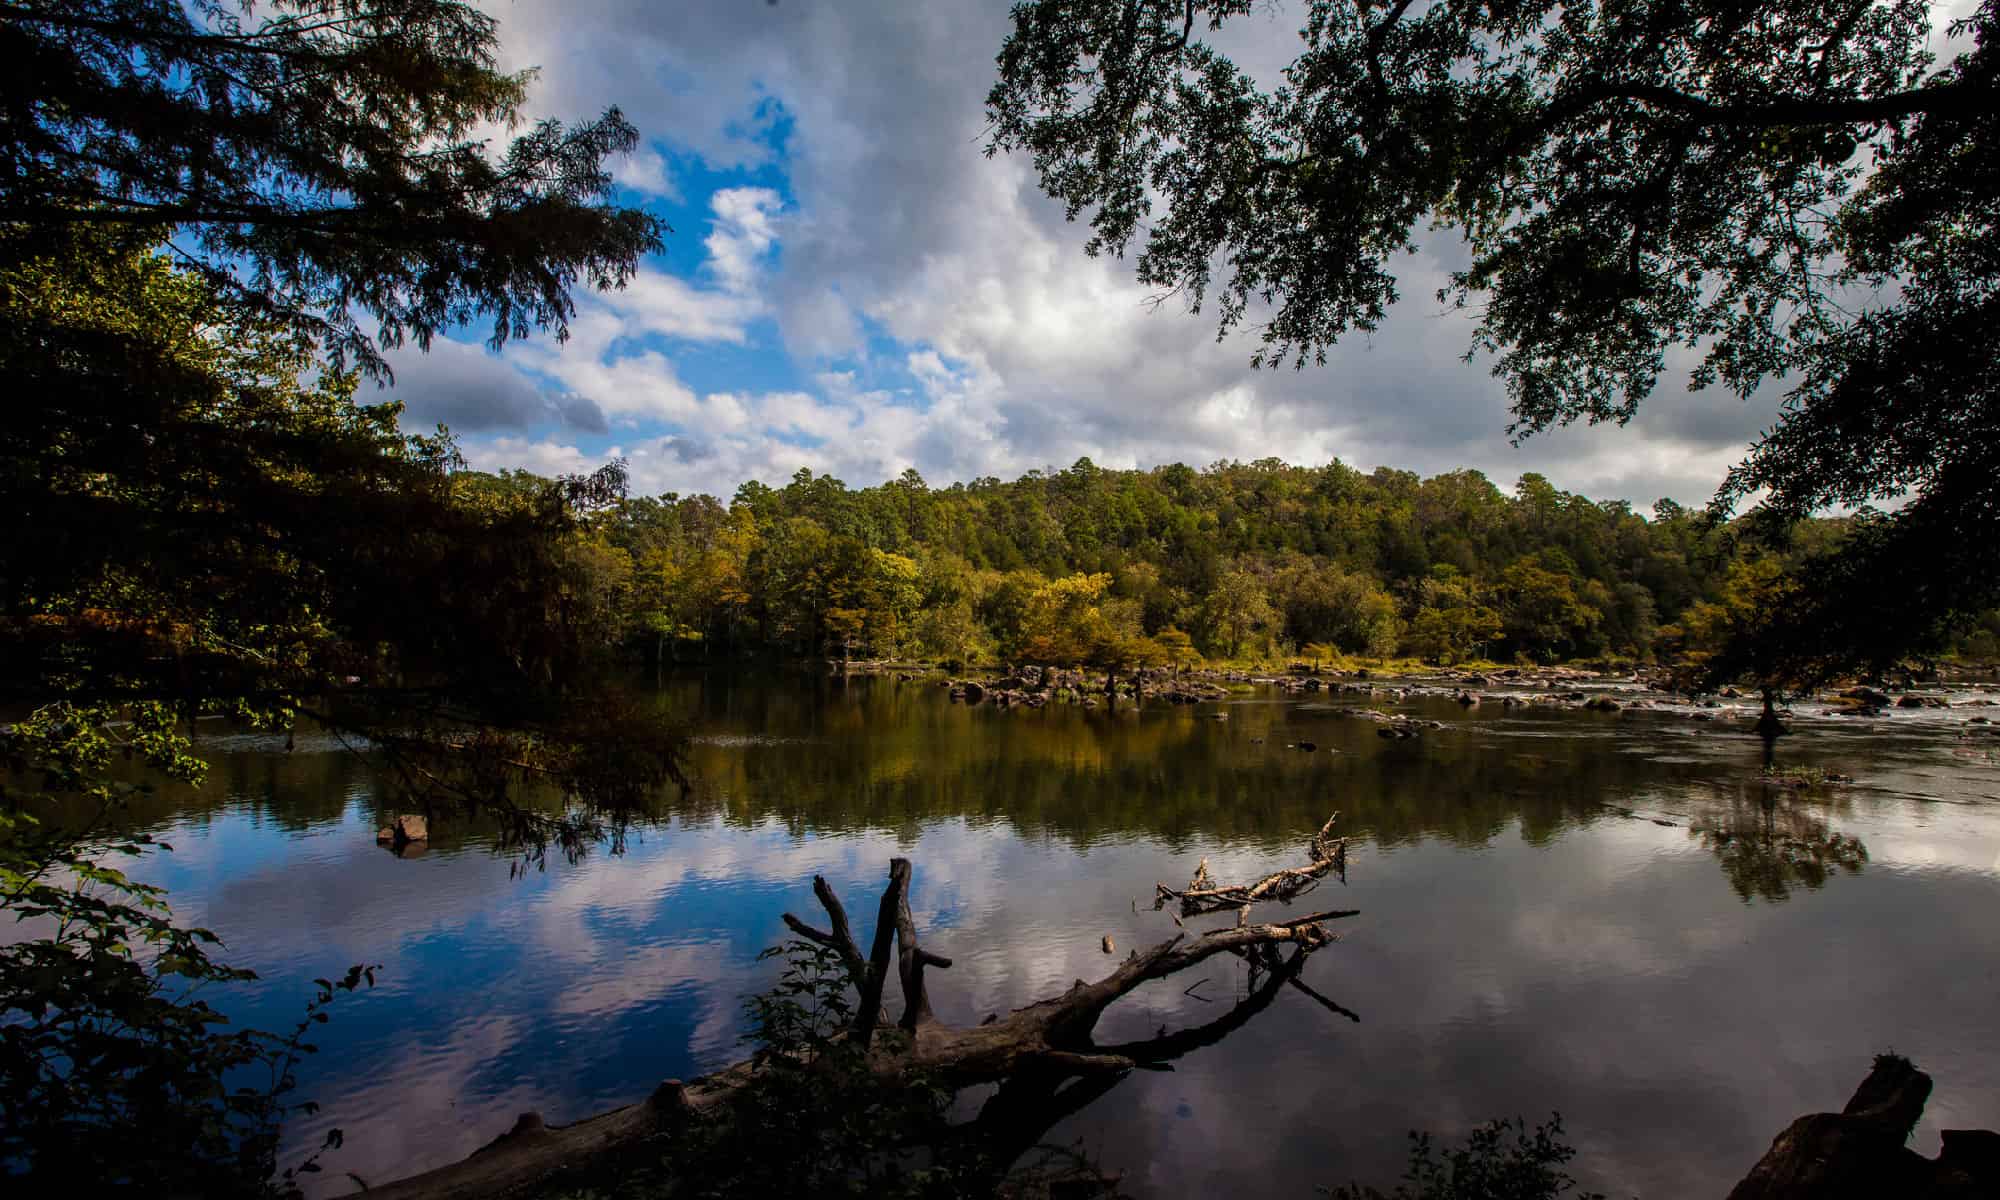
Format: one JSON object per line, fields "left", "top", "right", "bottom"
{"left": 0, "top": 0, "right": 664, "bottom": 370}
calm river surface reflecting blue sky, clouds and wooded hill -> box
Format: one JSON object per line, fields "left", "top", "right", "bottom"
{"left": 101, "top": 676, "right": 2000, "bottom": 1200}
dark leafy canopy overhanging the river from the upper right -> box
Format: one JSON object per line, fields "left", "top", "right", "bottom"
{"left": 988, "top": 0, "right": 2000, "bottom": 676}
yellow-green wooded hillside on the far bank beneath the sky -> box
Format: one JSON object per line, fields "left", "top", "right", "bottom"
{"left": 492, "top": 458, "right": 2000, "bottom": 666}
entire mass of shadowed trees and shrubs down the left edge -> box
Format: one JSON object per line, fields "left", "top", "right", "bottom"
{"left": 0, "top": 0, "right": 678, "bottom": 1196}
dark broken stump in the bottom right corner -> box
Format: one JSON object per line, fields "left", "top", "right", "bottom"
{"left": 1730, "top": 1054, "right": 2000, "bottom": 1200}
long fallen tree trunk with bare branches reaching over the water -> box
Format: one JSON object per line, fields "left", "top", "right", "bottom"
{"left": 370, "top": 820, "right": 1360, "bottom": 1200}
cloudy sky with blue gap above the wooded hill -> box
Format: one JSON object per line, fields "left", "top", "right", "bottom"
{"left": 372, "top": 0, "right": 1952, "bottom": 508}
